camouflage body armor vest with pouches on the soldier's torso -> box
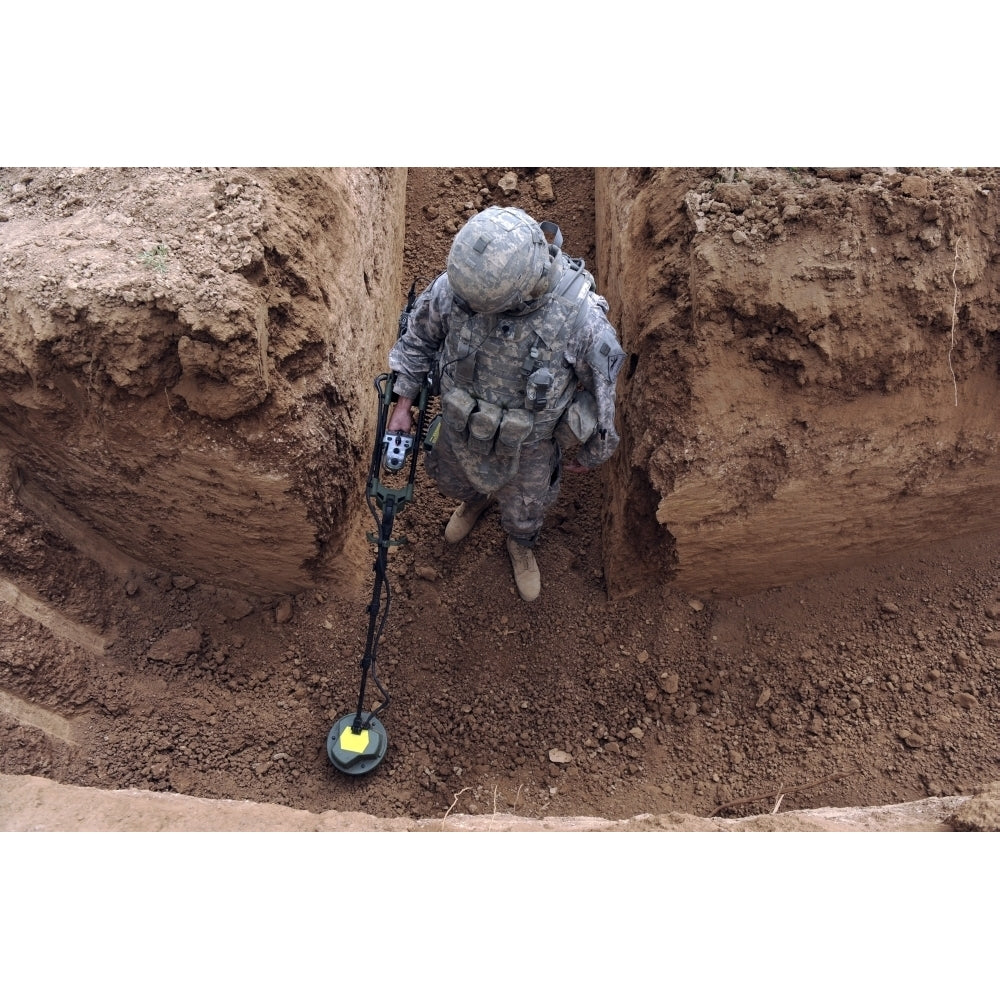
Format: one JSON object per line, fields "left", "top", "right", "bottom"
{"left": 440, "top": 255, "right": 594, "bottom": 493}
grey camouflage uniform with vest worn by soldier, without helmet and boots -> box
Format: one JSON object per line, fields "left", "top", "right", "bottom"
{"left": 389, "top": 258, "right": 624, "bottom": 547}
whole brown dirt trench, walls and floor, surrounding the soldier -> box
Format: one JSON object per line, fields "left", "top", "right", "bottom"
{"left": 0, "top": 168, "right": 1000, "bottom": 826}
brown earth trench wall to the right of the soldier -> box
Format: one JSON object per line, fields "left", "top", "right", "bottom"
{"left": 596, "top": 168, "right": 1000, "bottom": 596}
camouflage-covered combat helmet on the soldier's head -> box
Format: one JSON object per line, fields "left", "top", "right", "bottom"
{"left": 448, "top": 205, "right": 562, "bottom": 313}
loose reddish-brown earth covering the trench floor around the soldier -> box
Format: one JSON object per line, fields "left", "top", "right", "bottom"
{"left": 0, "top": 168, "right": 1000, "bottom": 828}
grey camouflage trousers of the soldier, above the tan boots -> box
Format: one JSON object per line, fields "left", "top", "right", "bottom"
{"left": 425, "top": 422, "right": 560, "bottom": 548}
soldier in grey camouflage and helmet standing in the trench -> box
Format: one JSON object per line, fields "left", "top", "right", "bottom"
{"left": 387, "top": 206, "right": 625, "bottom": 601}
